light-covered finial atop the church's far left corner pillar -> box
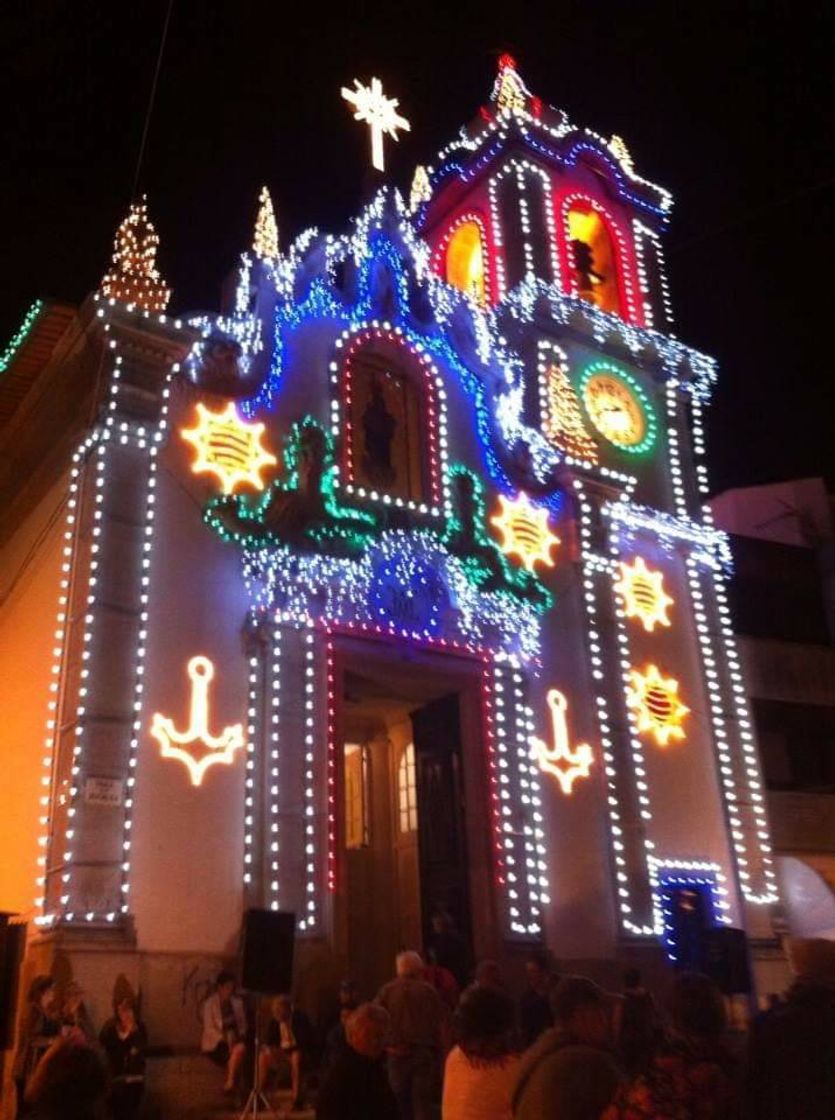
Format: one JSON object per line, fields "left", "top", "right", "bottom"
{"left": 101, "top": 195, "right": 171, "bottom": 311}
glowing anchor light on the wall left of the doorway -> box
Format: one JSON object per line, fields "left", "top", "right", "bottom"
{"left": 151, "top": 656, "right": 244, "bottom": 785}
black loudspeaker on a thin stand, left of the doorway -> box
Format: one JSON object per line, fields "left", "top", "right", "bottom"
{"left": 240, "top": 909, "right": 295, "bottom": 1120}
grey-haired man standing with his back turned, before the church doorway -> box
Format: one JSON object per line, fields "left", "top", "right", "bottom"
{"left": 376, "top": 951, "right": 448, "bottom": 1120}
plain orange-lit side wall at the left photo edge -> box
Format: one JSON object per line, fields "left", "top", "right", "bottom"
{"left": 0, "top": 483, "right": 65, "bottom": 917}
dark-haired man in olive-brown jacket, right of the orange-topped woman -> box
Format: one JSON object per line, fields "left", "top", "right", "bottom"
{"left": 513, "top": 977, "right": 620, "bottom": 1120}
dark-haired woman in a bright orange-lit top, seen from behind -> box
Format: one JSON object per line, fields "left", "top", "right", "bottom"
{"left": 442, "top": 986, "right": 519, "bottom": 1120}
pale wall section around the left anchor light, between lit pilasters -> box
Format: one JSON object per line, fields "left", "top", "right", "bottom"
{"left": 131, "top": 385, "right": 247, "bottom": 953}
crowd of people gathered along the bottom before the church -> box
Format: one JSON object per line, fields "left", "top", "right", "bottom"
{"left": 15, "top": 942, "right": 835, "bottom": 1120}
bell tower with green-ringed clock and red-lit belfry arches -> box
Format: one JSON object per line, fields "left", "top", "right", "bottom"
{"left": 412, "top": 55, "right": 777, "bottom": 964}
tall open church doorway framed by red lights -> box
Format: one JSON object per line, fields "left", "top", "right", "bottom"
{"left": 335, "top": 642, "right": 494, "bottom": 998}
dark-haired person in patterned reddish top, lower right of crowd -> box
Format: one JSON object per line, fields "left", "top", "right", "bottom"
{"left": 601, "top": 972, "right": 739, "bottom": 1120}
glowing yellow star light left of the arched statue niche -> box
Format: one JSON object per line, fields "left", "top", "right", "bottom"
{"left": 180, "top": 401, "right": 278, "bottom": 494}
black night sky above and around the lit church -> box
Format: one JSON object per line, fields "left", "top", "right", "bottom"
{"left": 0, "top": 0, "right": 835, "bottom": 491}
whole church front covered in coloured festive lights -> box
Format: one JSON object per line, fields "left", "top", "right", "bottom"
{"left": 3, "top": 58, "right": 777, "bottom": 1043}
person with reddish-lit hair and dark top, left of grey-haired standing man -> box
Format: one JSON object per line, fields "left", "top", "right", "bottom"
{"left": 316, "top": 1004, "right": 397, "bottom": 1120}
